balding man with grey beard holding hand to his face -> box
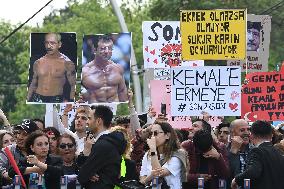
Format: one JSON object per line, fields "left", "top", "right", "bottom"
{"left": 228, "top": 119, "right": 251, "bottom": 187}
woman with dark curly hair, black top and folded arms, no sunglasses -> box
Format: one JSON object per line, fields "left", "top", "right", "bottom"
{"left": 9, "top": 131, "right": 62, "bottom": 189}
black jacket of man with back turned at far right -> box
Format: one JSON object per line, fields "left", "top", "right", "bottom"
{"left": 236, "top": 142, "right": 284, "bottom": 189}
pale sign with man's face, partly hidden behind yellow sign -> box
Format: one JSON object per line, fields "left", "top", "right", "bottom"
{"left": 227, "top": 14, "right": 271, "bottom": 72}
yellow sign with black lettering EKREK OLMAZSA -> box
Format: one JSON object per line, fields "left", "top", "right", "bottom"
{"left": 180, "top": 9, "right": 246, "bottom": 60}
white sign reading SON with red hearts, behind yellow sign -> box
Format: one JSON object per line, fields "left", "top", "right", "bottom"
{"left": 142, "top": 21, "right": 203, "bottom": 68}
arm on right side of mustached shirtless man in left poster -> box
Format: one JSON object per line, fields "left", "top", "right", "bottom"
{"left": 65, "top": 61, "right": 76, "bottom": 100}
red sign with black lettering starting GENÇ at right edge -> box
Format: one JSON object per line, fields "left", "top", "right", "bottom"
{"left": 242, "top": 68, "right": 284, "bottom": 121}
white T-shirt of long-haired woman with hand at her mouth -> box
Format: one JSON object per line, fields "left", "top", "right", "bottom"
{"left": 140, "top": 152, "right": 182, "bottom": 189}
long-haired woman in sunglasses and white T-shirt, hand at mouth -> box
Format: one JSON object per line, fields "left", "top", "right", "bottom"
{"left": 140, "top": 122, "right": 187, "bottom": 189}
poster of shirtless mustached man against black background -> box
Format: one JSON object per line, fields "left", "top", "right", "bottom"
{"left": 27, "top": 33, "right": 77, "bottom": 103}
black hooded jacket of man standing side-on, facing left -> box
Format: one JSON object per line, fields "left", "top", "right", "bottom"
{"left": 78, "top": 132, "right": 126, "bottom": 189}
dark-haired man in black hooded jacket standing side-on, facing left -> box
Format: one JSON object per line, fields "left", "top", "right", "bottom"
{"left": 78, "top": 106, "right": 127, "bottom": 189}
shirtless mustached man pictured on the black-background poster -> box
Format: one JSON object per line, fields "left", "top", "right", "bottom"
{"left": 27, "top": 33, "right": 76, "bottom": 103}
